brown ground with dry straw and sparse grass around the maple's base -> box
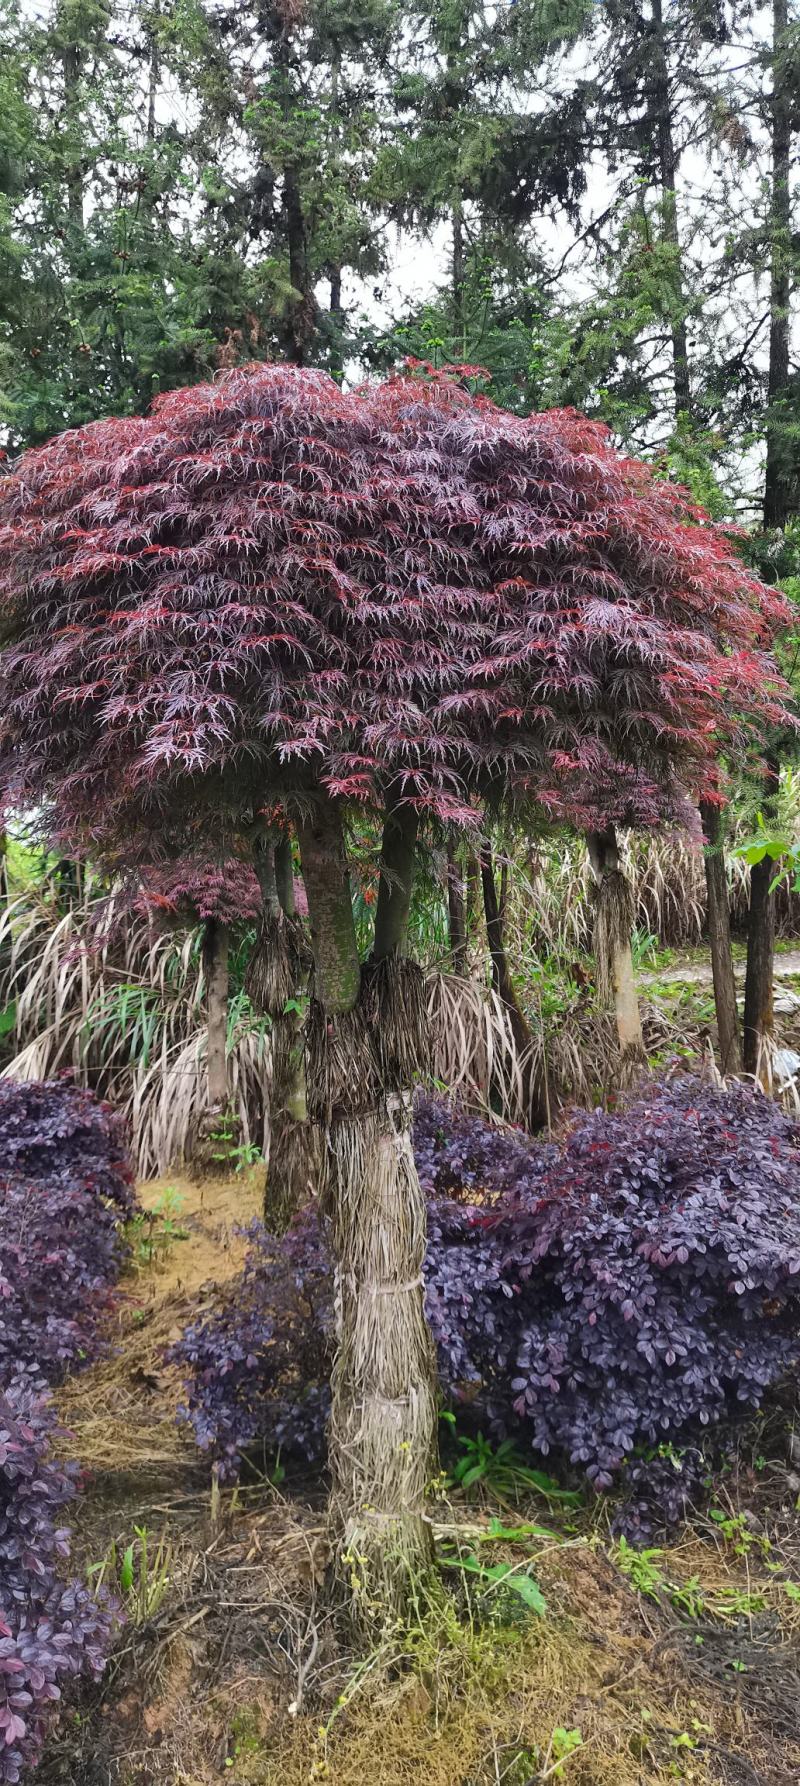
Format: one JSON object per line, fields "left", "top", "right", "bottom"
{"left": 39, "top": 1175, "right": 800, "bottom": 1786}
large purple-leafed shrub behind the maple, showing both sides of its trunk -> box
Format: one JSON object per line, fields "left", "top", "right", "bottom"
{"left": 177, "top": 1079, "right": 800, "bottom": 1532}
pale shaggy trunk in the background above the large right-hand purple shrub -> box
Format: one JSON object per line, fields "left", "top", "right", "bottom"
{"left": 586, "top": 825, "right": 645, "bottom": 1077}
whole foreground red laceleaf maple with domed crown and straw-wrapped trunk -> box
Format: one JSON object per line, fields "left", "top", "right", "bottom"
{"left": 0, "top": 366, "right": 782, "bottom": 1609}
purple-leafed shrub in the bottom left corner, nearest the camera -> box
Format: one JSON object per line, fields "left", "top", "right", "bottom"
{"left": 0, "top": 1386, "right": 113, "bottom": 1786}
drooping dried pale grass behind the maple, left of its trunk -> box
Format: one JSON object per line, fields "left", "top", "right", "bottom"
{"left": 0, "top": 879, "right": 270, "bottom": 1179}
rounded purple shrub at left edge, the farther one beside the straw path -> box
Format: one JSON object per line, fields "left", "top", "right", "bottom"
{"left": 0, "top": 1081, "right": 134, "bottom": 1388}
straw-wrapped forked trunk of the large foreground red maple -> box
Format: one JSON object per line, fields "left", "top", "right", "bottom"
{"left": 298, "top": 795, "right": 438, "bottom": 1627}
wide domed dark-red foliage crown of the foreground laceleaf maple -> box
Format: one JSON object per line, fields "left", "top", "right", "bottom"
{"left": 0, "top": 366, "right": 784, "bottom": 839}
